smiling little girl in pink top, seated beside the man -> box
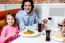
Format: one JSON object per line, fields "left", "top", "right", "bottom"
{"left": 0, "top": 13, "right": 18, "bottom": 43}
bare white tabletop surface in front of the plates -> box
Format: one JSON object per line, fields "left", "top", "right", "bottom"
{"left": 11, "top": 35, "right": 63, "bottom": 43}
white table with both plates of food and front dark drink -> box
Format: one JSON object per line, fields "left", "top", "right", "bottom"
{"left": 11, "top": 28, "right": 65, "bottom": 43}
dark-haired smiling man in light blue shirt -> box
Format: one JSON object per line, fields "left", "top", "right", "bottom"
{"left": 16, "top": 0, "right": 43, "bottom": 30}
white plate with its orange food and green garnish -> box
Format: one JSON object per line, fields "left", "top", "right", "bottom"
{"left": 19, "top": 30, "right": 39, "bottom": 37}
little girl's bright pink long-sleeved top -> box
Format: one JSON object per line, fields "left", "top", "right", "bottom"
{"left": 0, "top": 25, "right": 18, "bottom": 43}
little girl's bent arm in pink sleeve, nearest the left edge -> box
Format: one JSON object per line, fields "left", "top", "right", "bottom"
{"left": 1, "top": 27, "right": 16, "bottom": 42}
